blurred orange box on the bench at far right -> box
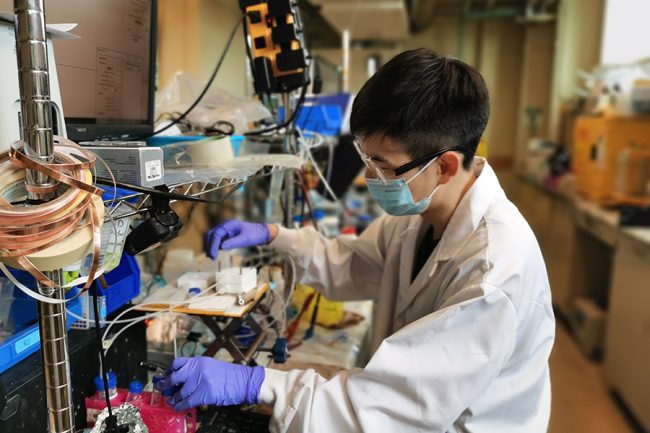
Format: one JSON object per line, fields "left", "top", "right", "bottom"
{"left": 573, "top": 116, "right": 650, "bottom": 205}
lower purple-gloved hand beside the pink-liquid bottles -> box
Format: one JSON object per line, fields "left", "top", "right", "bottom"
{"left": 156, "top": 357, "right": 264, "bottom": 411}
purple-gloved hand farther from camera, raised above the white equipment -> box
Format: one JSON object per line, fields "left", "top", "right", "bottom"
{"left": 205, "top": 220, "right": 271, "bottom": 260}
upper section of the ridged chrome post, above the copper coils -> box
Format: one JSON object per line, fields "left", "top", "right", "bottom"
{"left": 14, "top": 0, "right": 54, "bottom": 200}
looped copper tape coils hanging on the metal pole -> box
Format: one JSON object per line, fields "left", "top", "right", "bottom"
{"left": 0, "top": 137, "right": 103, "bottom": 290}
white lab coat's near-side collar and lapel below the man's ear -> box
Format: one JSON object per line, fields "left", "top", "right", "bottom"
{"left": 431, "top": 157, "right": 504, "bottom": 264}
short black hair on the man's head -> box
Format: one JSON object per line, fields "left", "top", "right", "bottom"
{"left": 350, "top": 48, "right": 490, "bottom": 170}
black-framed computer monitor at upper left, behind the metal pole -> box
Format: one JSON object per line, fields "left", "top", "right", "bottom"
{"left": 0, "top": 0, "right": 156, "bottom": 141}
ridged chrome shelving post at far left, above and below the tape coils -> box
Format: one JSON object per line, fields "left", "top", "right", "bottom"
{"left": 14, "top": 0, "right": 75, "bottom": 433}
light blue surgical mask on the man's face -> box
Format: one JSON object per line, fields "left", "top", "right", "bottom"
{"left": 366, "top": 158, "right": 440, "bottom": 216}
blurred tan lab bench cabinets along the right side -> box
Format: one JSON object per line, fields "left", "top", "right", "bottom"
{"left": 515, "top": 171, "right": 650, "bottom": 431}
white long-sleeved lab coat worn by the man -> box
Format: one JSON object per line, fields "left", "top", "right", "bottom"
{"left": 260, "top": 159, "right": 555, "bottom": 433}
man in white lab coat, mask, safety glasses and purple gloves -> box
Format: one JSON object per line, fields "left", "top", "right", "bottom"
{"left": 160, "top": 49, "right": 555, "bottom": 433}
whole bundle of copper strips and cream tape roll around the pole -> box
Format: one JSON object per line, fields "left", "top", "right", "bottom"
{"left": 0, "top": 136, "right": 104, "bottom": 289}
